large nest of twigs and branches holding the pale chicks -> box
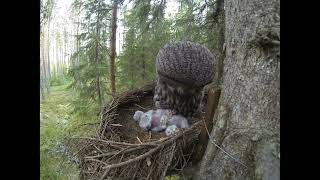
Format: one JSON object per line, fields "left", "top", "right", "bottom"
{"left": 69, "top": 82, "right": 218, "bottom": 180}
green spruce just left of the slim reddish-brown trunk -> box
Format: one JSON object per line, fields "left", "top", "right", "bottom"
{"left": 70, "top": 0, "right": 110, "bottom": 115}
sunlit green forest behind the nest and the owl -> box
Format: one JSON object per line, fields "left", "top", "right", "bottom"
{"left": 40, "top": 0, "right": 224, "bottom": 179}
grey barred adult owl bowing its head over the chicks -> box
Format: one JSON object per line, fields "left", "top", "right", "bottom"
{"left": 153, "top": 41, "right": 215, "bottom": 119}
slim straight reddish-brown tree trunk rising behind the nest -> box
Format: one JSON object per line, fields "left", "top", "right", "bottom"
{"left": 110, "top": 0, "right": 118, "bottom": 96}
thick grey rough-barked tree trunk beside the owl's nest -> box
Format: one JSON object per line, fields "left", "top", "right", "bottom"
{"left": 194, "top": 0, "right": 280, "bottom": 180}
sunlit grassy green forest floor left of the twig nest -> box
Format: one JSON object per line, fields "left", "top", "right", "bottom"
{"left": 40, "top": 85, "right": 78, "bottom": 180}
